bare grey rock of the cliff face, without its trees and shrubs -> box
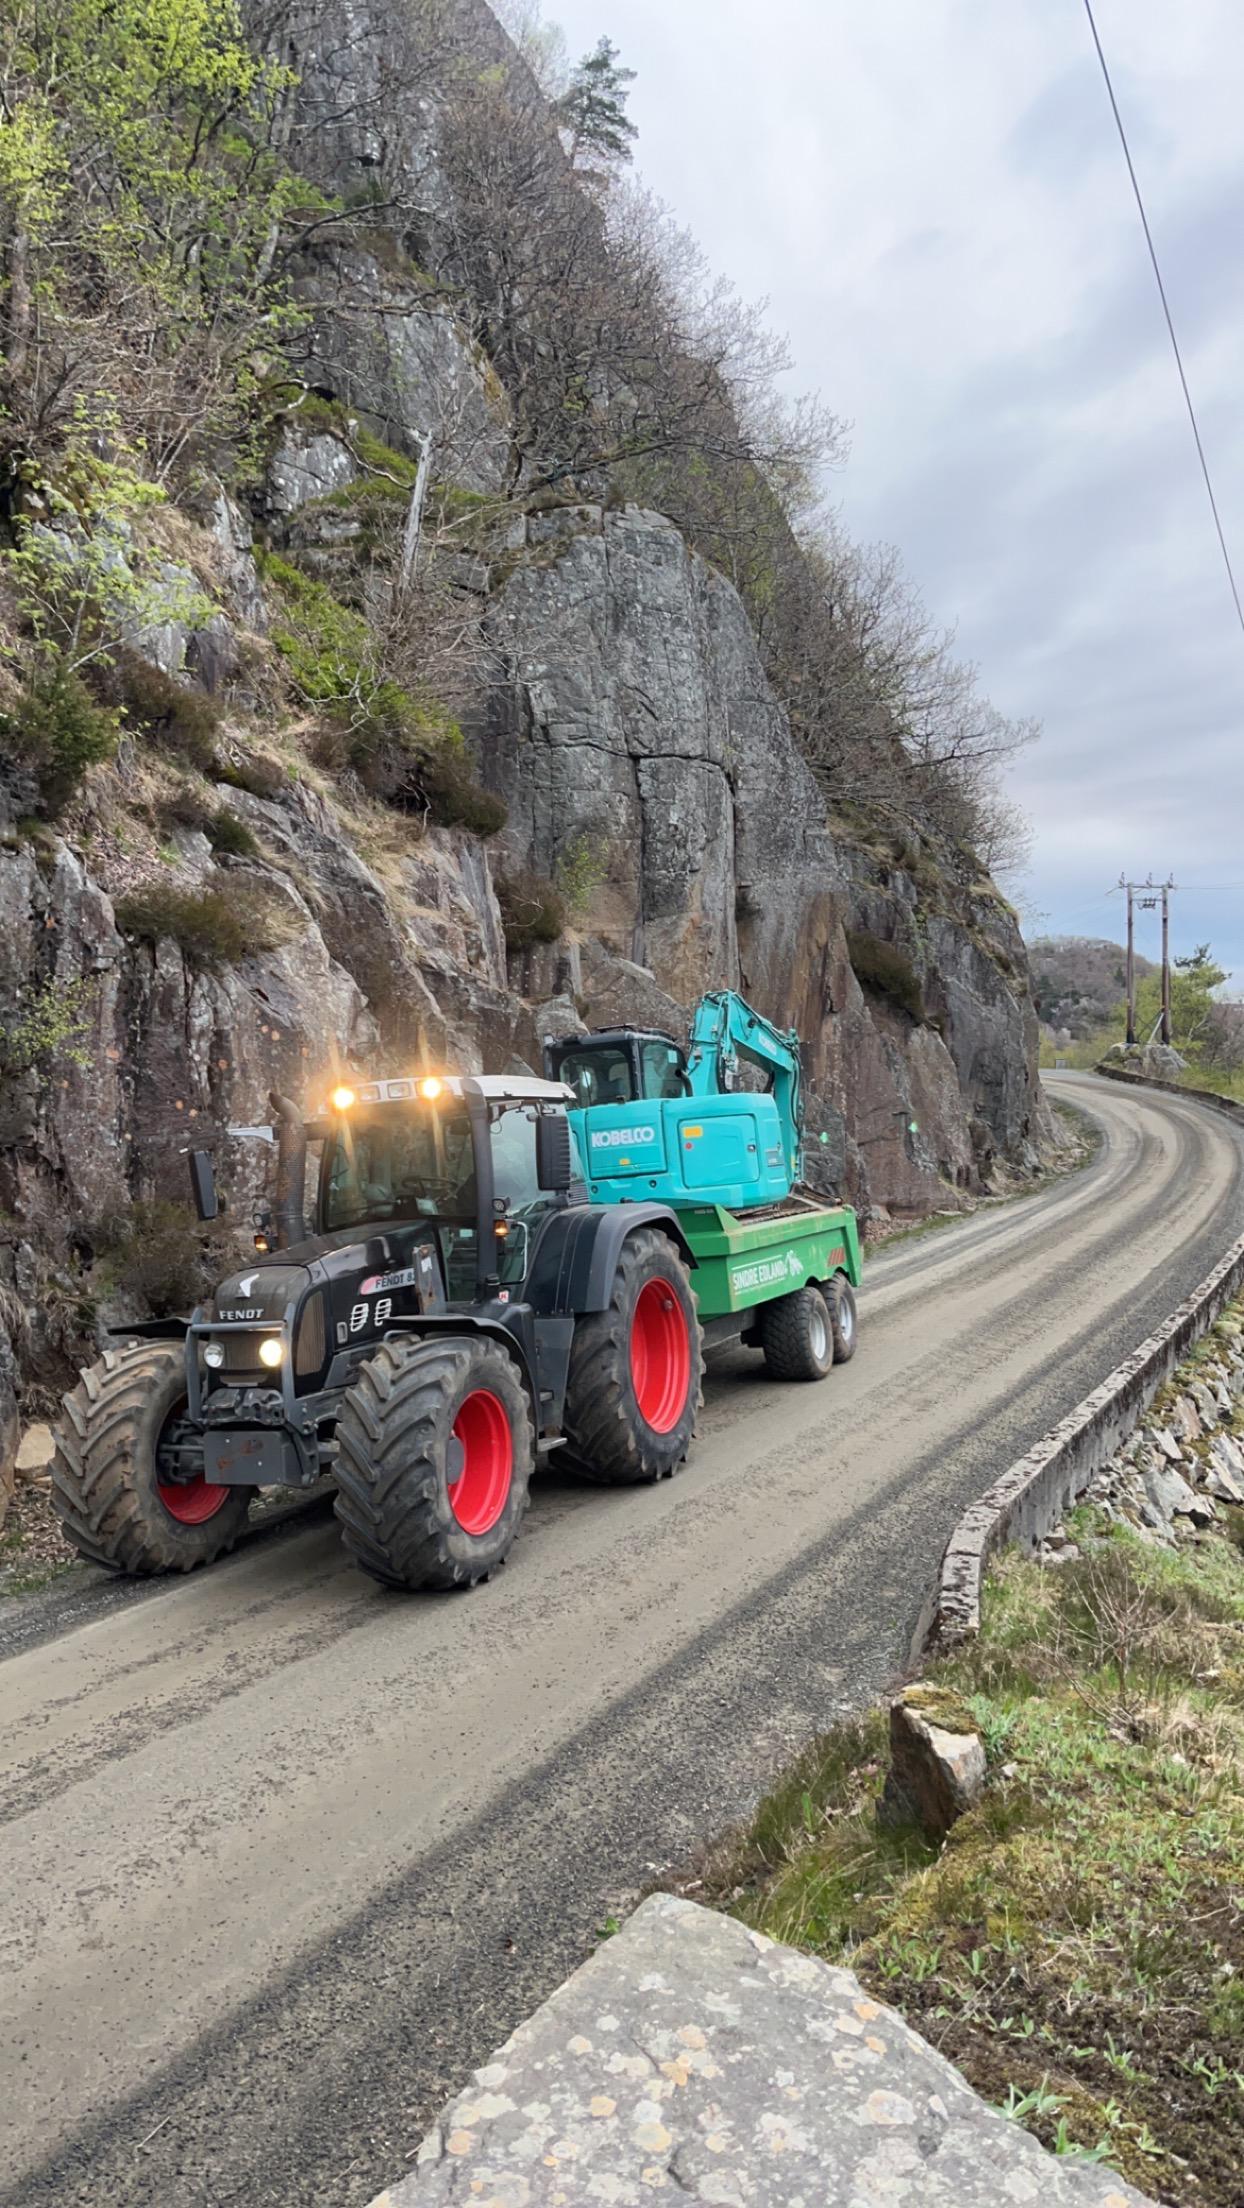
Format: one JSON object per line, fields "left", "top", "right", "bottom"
{"left": 0, "top": 4, "right": 1043, "bottom": 1501}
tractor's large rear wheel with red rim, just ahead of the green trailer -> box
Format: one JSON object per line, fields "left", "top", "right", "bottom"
{"left": 566, "top": 1228, "right": 705, "bottom": 1488}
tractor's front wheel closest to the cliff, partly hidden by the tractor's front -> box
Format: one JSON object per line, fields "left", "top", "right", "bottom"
{"left": 51, "top": 1342, "right": 252, "bottom": 1574}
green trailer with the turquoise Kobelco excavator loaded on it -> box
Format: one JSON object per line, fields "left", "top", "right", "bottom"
{"left": 544, "top": 989, "right": 860, "bottom": 1380}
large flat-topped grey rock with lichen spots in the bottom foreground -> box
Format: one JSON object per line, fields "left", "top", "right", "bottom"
{"left": 373, "top": 1894, "right": 1145, "bottom": 2208}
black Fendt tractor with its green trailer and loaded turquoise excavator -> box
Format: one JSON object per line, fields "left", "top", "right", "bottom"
{"left": 53, "top": 1000, "right": 860, "bottom": 1588}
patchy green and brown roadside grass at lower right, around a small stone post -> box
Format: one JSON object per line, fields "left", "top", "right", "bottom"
{"left": 676, "top": 1512, "right": 1244, "bottom": 2208}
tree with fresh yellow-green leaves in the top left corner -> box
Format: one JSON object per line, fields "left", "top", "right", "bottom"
{"left": 0, "top": 0, "right": 311, "bottom": 477}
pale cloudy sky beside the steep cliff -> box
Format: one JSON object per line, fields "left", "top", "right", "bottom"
{"left": 546, "top": 0, "right": 1244, "bottom": 987}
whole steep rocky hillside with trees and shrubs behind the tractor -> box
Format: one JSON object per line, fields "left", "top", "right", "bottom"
{"left": 0, "top": 0, "right": 1043, "bottom": 1483}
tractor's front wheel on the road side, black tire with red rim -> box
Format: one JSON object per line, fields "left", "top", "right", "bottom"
{"left": 334, "top": 1340, "right": 535, "bottom": 1588}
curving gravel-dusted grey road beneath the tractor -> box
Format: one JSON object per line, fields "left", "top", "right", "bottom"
{"left": 0, "top": 1078, "right": 1244, "bottom": 2208}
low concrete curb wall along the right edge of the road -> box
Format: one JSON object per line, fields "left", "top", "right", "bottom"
{"left": 941, "top": 1069, "right": 1244, "bottom": 1652}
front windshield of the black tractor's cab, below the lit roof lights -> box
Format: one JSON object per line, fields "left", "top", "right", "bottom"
{"left": 323, "top": 1104, "right": 475, "bottom": 1234}
